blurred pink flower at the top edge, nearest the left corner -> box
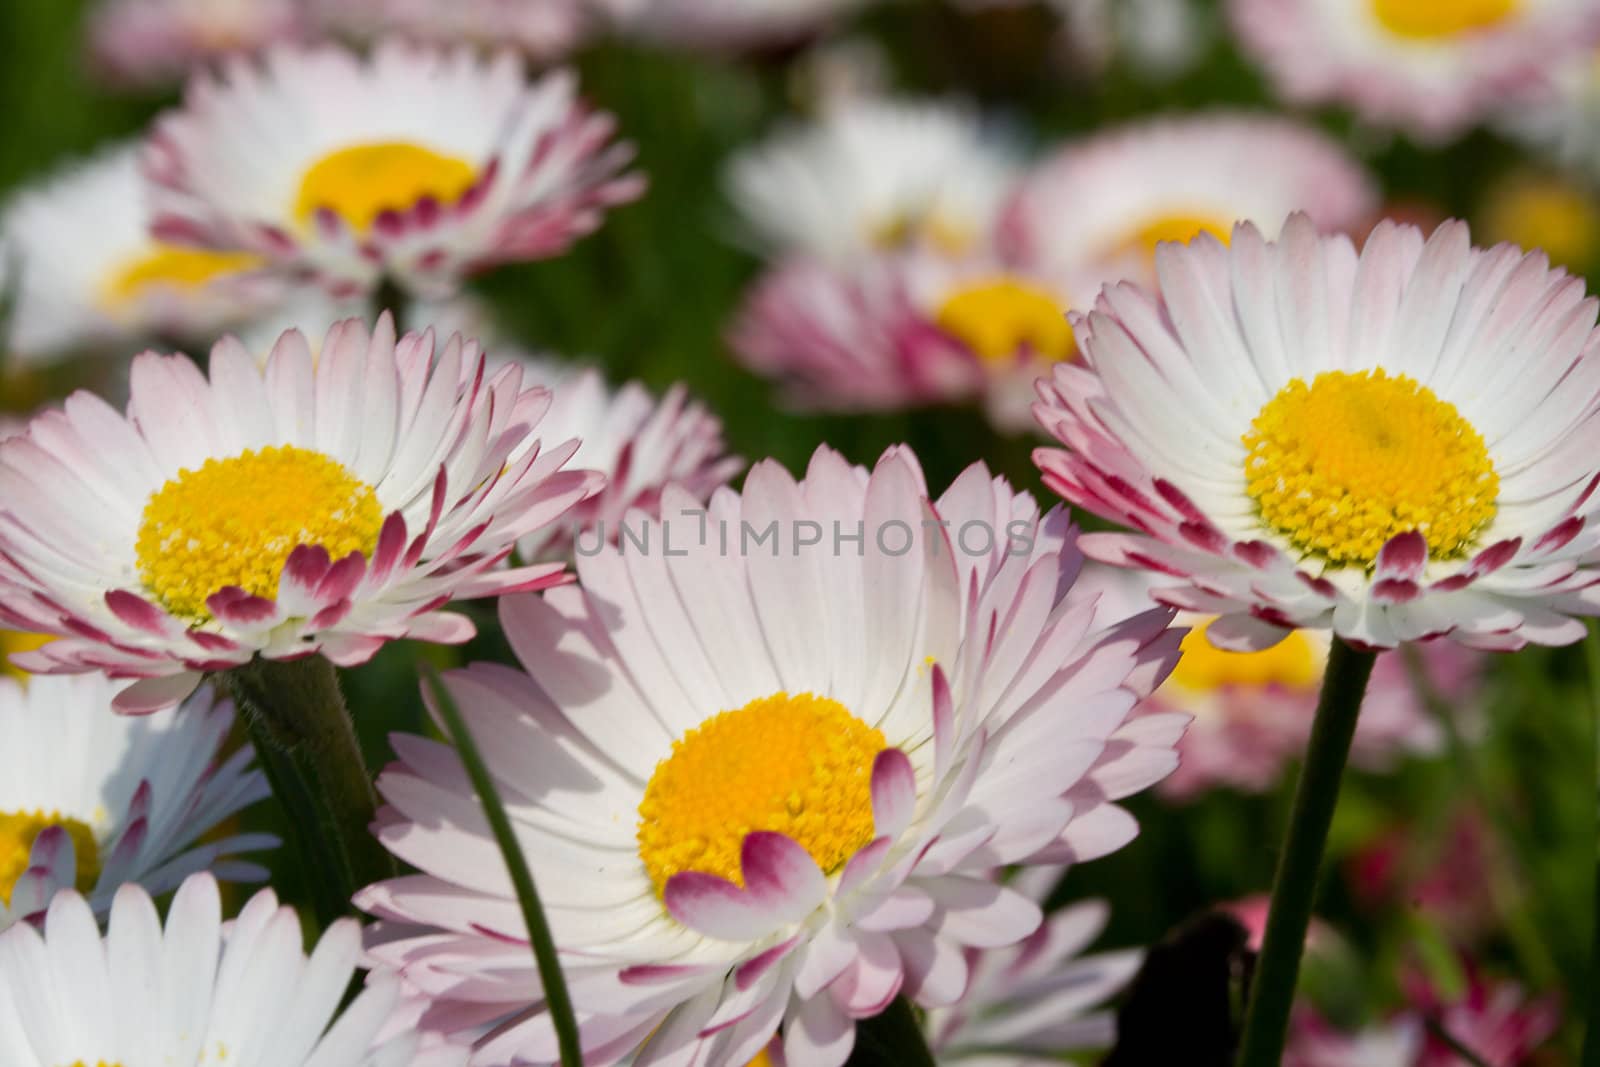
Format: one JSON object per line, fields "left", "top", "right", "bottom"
{"left": 88, "top": 0, "right": 309, "bottom": 85}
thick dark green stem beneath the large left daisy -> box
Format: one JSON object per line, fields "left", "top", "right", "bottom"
{"left": 227, "top": 656, "right": 395, "bottom": 912}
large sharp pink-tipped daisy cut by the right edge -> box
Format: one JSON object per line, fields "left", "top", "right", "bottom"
{"left": 1035, "top": 216, "right": 1600, "bottom": 651}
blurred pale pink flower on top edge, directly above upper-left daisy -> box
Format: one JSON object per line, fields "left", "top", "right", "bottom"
{"left": 312, "top": 0, "right": 598, "bottom": 61}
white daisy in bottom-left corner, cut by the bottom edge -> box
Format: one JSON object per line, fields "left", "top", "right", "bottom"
{"left": 0, "top": 873, "right": 464, "bottom": 1067}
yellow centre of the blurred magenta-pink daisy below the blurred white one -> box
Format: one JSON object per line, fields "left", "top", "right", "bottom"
{"left": 934, "top": 277, "right": 1077, "bottom": 365}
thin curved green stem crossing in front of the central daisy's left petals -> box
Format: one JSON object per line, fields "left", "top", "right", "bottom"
{"left": 422, "top": 662, "right": 584, "bottom": 1067}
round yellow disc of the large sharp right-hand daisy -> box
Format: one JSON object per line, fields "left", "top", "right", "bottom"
{"left": 1242, "top": 370, "right": 1499, "bottom": 568}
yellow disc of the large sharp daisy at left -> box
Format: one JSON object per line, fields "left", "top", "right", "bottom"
{"left": 138, "top": 445, "right": 384, "bottom": 619}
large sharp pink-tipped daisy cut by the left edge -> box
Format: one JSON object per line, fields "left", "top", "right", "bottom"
{"left": 0, "top": 315, "right": 600, "bottom": 712}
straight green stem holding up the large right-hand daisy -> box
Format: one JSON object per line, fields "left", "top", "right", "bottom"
{"left": 1238, "top": 640, "right": 1378, "bottom": 1067}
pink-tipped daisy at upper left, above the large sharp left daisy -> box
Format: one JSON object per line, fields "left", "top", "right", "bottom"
{"left": 144, "top": 42, "right": 642, "bottom": 296}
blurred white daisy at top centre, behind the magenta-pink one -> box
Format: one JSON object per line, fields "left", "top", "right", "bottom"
{"left": 726, "top": 98, "right": 1016, "bottom": 264}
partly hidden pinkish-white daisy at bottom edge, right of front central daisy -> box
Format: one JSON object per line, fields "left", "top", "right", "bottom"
{"left": 928, "top": 867, "right": 1144, "bottom": 1067}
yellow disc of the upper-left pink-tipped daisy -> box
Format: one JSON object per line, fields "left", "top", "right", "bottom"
{"left": 294, "top": 141, "right": 477, "bottom": 234}
